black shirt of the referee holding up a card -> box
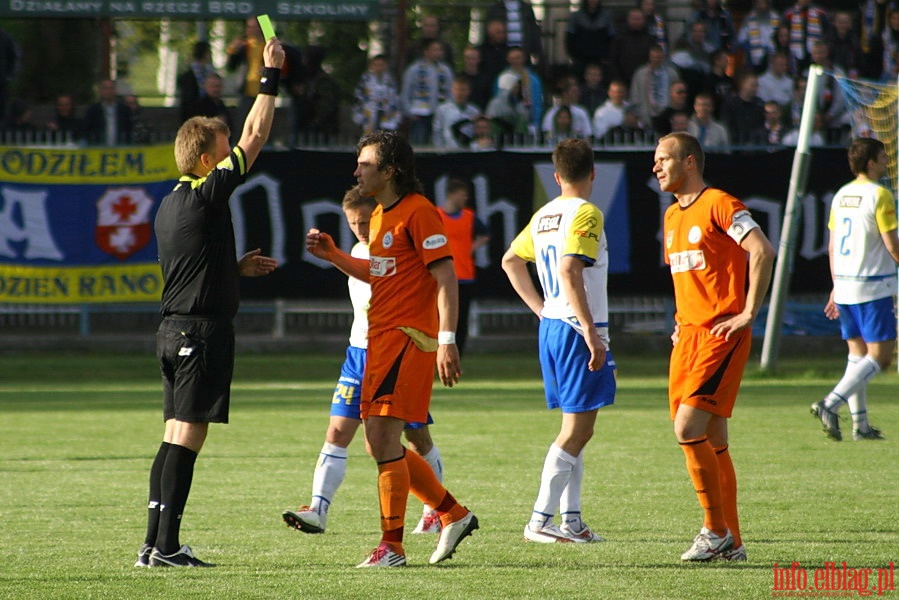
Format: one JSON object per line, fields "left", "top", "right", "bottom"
{"left": 155, "top": 147, "right": 247, "bottom": 320}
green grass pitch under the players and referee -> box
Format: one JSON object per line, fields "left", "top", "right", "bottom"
{"left": 0, "top": 353, "right": 899, "bottom": 600}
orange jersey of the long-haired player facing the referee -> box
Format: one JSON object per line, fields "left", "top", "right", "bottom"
{"left": 368, "top": 194, "right": 452, "bottom": 339}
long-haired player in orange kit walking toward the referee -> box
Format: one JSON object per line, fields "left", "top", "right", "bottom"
{"left": 306, "top": 131, "right": 478, "bottom": 567}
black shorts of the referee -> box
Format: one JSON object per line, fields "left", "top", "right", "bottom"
{"left": 156, "top": 317, "right": 234, "bottom": 423}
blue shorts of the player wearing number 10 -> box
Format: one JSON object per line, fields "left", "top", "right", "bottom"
{"left": 540, "top": 319, "right": 616, "bottom": 413}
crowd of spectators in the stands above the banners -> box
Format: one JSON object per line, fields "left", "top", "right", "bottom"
{"left": 4, "top": 0, "right": 899, "bottom": 150}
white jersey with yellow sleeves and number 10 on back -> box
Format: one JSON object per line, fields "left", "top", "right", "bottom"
{"left": 512, "top": 197, "right": 609, "bottom": 344}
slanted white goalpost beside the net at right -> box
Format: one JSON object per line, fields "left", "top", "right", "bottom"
{"left": 761, "top": 65, "right": 824, "bottom": 371}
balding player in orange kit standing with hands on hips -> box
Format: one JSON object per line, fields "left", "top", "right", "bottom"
{"left": 652, "top": 133, "right": 774, "bottom": 561}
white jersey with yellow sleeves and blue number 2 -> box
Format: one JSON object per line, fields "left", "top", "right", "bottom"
{"left": 827, "top": 179, "right": 896, "bottom": 304}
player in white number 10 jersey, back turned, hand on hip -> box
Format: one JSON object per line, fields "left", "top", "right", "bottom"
{"left": 503, "top": 139, "right": 616, "bottom": 543}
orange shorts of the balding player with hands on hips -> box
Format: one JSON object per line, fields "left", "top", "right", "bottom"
{"left": 668, "top": 325, "right": 752, "bottom": 421}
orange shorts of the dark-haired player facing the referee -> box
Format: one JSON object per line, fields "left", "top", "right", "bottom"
{"left": 360, "top": 329, "right": 437, "bottom": 423}
